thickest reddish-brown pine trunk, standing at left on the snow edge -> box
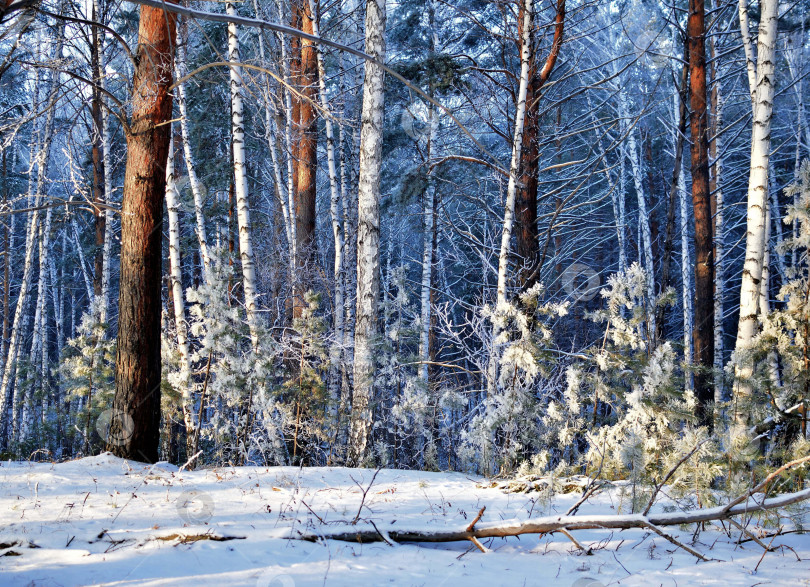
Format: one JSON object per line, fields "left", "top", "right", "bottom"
{"left": 110, "top": 6, "right": 176, "bottom": 462}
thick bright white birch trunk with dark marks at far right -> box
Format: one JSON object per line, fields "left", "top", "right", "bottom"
{"left": 734, "top": 0, "right": 779, "bottom": 425}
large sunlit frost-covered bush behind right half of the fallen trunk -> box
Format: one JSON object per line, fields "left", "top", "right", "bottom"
{"left": 543, "top": 263, "right": 718, "bottom": 511}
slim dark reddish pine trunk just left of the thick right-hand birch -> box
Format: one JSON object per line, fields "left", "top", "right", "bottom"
{"left": 686, "top": 0, "right": 714, "bottom": 426}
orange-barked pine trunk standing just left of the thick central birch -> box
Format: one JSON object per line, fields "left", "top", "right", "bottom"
{"left": 292, "top": 0, "right": 318, "bottom": 318}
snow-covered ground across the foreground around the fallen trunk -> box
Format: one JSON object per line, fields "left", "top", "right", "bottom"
{"left": 0, "top": 455, "right": 810, "bottom": 587}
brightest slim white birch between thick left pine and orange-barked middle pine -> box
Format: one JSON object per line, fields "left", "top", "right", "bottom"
{"left": 226, "top": 2, "right": 259, "bottom": 348}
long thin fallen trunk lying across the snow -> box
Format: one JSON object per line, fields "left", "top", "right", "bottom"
{"left": 290, "top": 489, "right": 810, "bottom": 543}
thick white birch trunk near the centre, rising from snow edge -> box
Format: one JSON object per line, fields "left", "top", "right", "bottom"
{"left": 349, "top": 0, "right": 386, "bottom": 464}
